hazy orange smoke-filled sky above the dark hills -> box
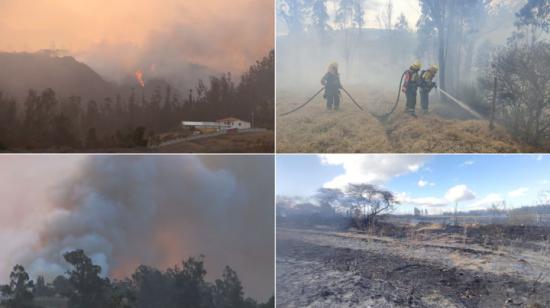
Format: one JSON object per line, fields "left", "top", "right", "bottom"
{"left": 0, "top": 0, "right": 274, "bottom": 76}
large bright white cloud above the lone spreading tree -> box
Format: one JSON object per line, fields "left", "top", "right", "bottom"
{"left": 319, "top": 154, "right": 428, "bottom": 188}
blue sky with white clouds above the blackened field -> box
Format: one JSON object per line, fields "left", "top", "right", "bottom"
{"left": 277, "top": 154, "right": 550, "bottom": 213}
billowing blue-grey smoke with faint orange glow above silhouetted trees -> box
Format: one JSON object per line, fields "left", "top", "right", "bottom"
{"left": 0, "top": 156, "right": 274, "bottom": 300}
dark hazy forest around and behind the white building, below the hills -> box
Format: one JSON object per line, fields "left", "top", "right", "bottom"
{"left": 0, "top": 51, "right": 275, "bottom": 150}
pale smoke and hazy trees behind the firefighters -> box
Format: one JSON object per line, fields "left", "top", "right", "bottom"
{"left": 277, "top": 0, "right": 550, "bottom": 149}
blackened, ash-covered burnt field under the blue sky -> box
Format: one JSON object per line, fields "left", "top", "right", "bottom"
{"left": 277, "top": 223, "right": 550, "bottom": 307}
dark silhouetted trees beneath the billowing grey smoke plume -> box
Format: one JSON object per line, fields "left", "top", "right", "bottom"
{"left": 0, "top": 250, "right": 274, "bottom": 308}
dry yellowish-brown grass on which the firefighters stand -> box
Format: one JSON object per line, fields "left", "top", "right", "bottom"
{"left": 277, "top": 86, "right": 537, "bottom": 153}
